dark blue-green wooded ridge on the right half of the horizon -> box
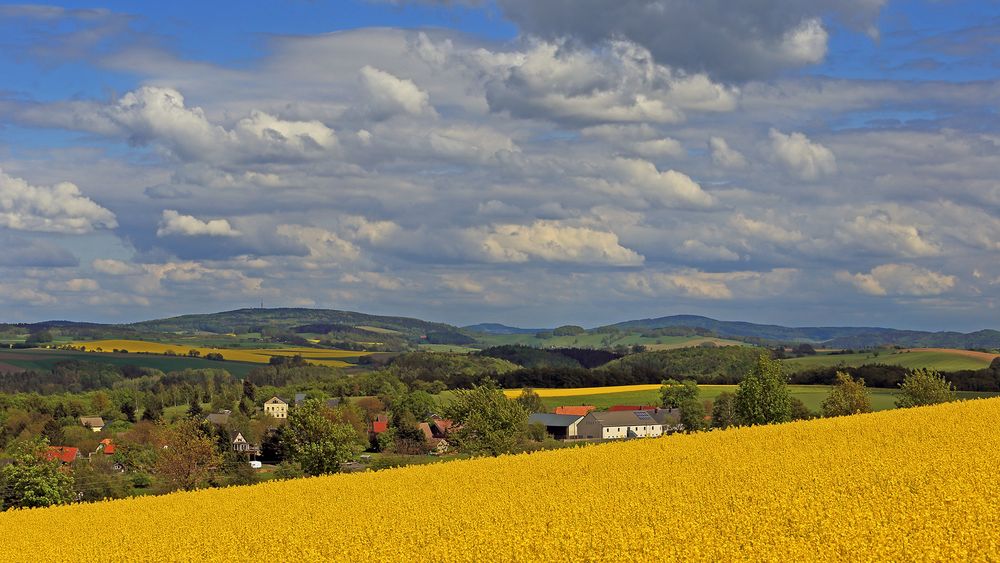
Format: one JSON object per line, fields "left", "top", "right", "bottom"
{"left": 610, "top": 315, "right": 1000, "bottom": 349}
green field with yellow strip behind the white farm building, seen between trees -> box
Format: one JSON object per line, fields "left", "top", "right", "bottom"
{"left": 504, "top": 385, "right": 997, "bottom": 412}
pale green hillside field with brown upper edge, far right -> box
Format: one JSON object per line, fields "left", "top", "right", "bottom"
{"left": 782, "top": 350, "right": 990, "bottom": 372}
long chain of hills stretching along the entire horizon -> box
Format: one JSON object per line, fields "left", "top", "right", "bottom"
{"left": 7, "top": 308, "right": 1000, "bottom": 350}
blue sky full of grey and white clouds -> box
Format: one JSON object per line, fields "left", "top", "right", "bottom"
{"left": 0, "top": 0, "right": 1000, "bottom": 331}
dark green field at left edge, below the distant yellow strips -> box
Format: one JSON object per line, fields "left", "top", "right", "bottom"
{"left": 0, "top": 349, "right": 257, "bottom": 377}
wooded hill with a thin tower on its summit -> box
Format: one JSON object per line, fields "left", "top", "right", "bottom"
{"left": 128, "top": 308, "right": 456, "bottom": 334}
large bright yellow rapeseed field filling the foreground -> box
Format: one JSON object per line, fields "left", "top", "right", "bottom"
{"left": 0, "top": 399, "right": 1000, "bottom": 562}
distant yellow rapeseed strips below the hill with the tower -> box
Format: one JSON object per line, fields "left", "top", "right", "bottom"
{"left": 71, "top": 340, "right": 369, "bottom": 367}
